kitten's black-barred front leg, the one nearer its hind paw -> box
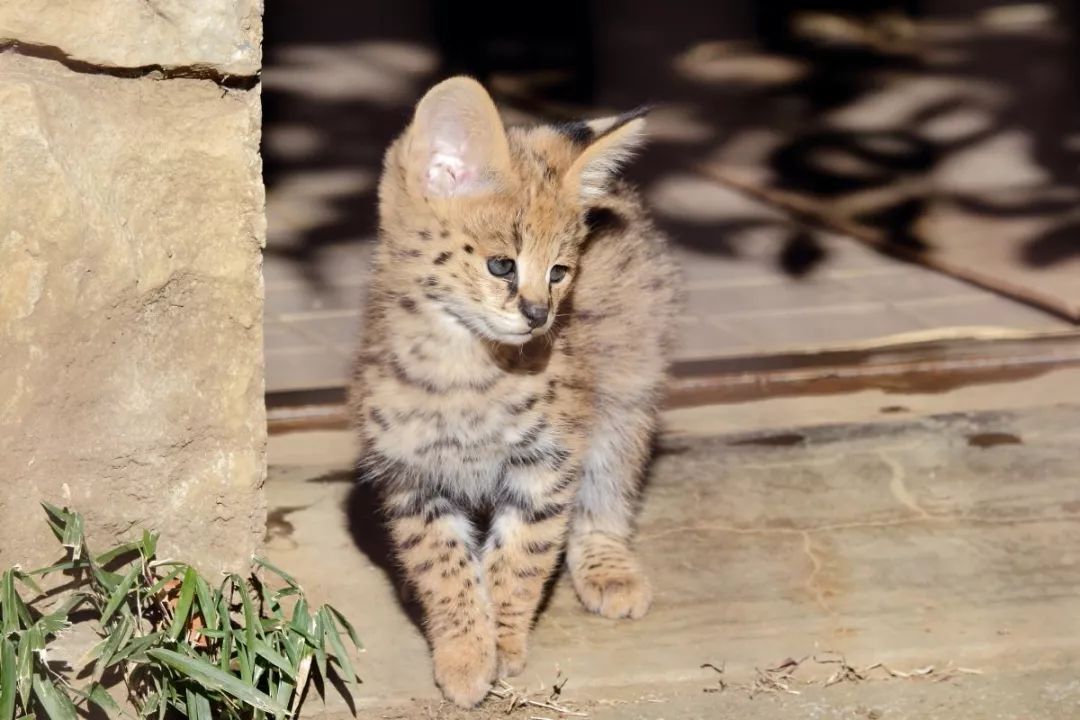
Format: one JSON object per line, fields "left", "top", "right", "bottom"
{"left": 484, "top": 465, "right": 578, "bottom": 676}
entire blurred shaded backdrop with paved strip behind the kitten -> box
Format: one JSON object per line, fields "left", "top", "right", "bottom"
{"left": 264, "top": 0, "right": 1080, "bottom": 391}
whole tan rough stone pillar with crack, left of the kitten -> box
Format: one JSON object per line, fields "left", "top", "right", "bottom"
{"left": 0, "top": 0, "right": 266, "bottom": 572}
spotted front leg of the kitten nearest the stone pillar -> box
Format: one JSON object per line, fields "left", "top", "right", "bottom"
{"left": 384, "top": 490, "right": 496, "bottom": 707}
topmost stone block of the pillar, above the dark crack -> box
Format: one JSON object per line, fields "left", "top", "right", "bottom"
{"left": 0, "top": 0, "right": 262, "bottom": 76}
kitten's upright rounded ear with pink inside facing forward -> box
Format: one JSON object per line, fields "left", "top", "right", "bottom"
{"left": 405, "top": 77, "right": 510, "bottom": 198}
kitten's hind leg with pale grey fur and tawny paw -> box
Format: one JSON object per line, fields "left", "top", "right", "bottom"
{"left": 566, "top": 408, "right": 654, "bottom": 619}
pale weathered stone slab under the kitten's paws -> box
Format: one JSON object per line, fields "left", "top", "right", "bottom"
{"left": 268, "top": 370, "right": 1080, "bottom": 720}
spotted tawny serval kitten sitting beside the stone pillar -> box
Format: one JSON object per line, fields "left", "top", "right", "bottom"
{"left": 351, "top": 78, "right": 677, "bottom": 706}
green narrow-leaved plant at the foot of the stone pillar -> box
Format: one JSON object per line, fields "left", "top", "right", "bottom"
{"left": 0, "top": 504, "right": 361, "bottom": 720}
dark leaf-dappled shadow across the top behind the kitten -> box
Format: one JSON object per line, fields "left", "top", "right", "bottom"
{"left": 264, "top": 0, "right": 1080, "bottom": 315}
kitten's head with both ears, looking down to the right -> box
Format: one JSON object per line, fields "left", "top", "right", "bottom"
{"left": 381, "top": 78, "right": 644, "bottom": 345}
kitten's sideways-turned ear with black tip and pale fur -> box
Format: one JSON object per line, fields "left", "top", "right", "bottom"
{"left": 563, "top": 107, "right": 649, "bottom": 200}
